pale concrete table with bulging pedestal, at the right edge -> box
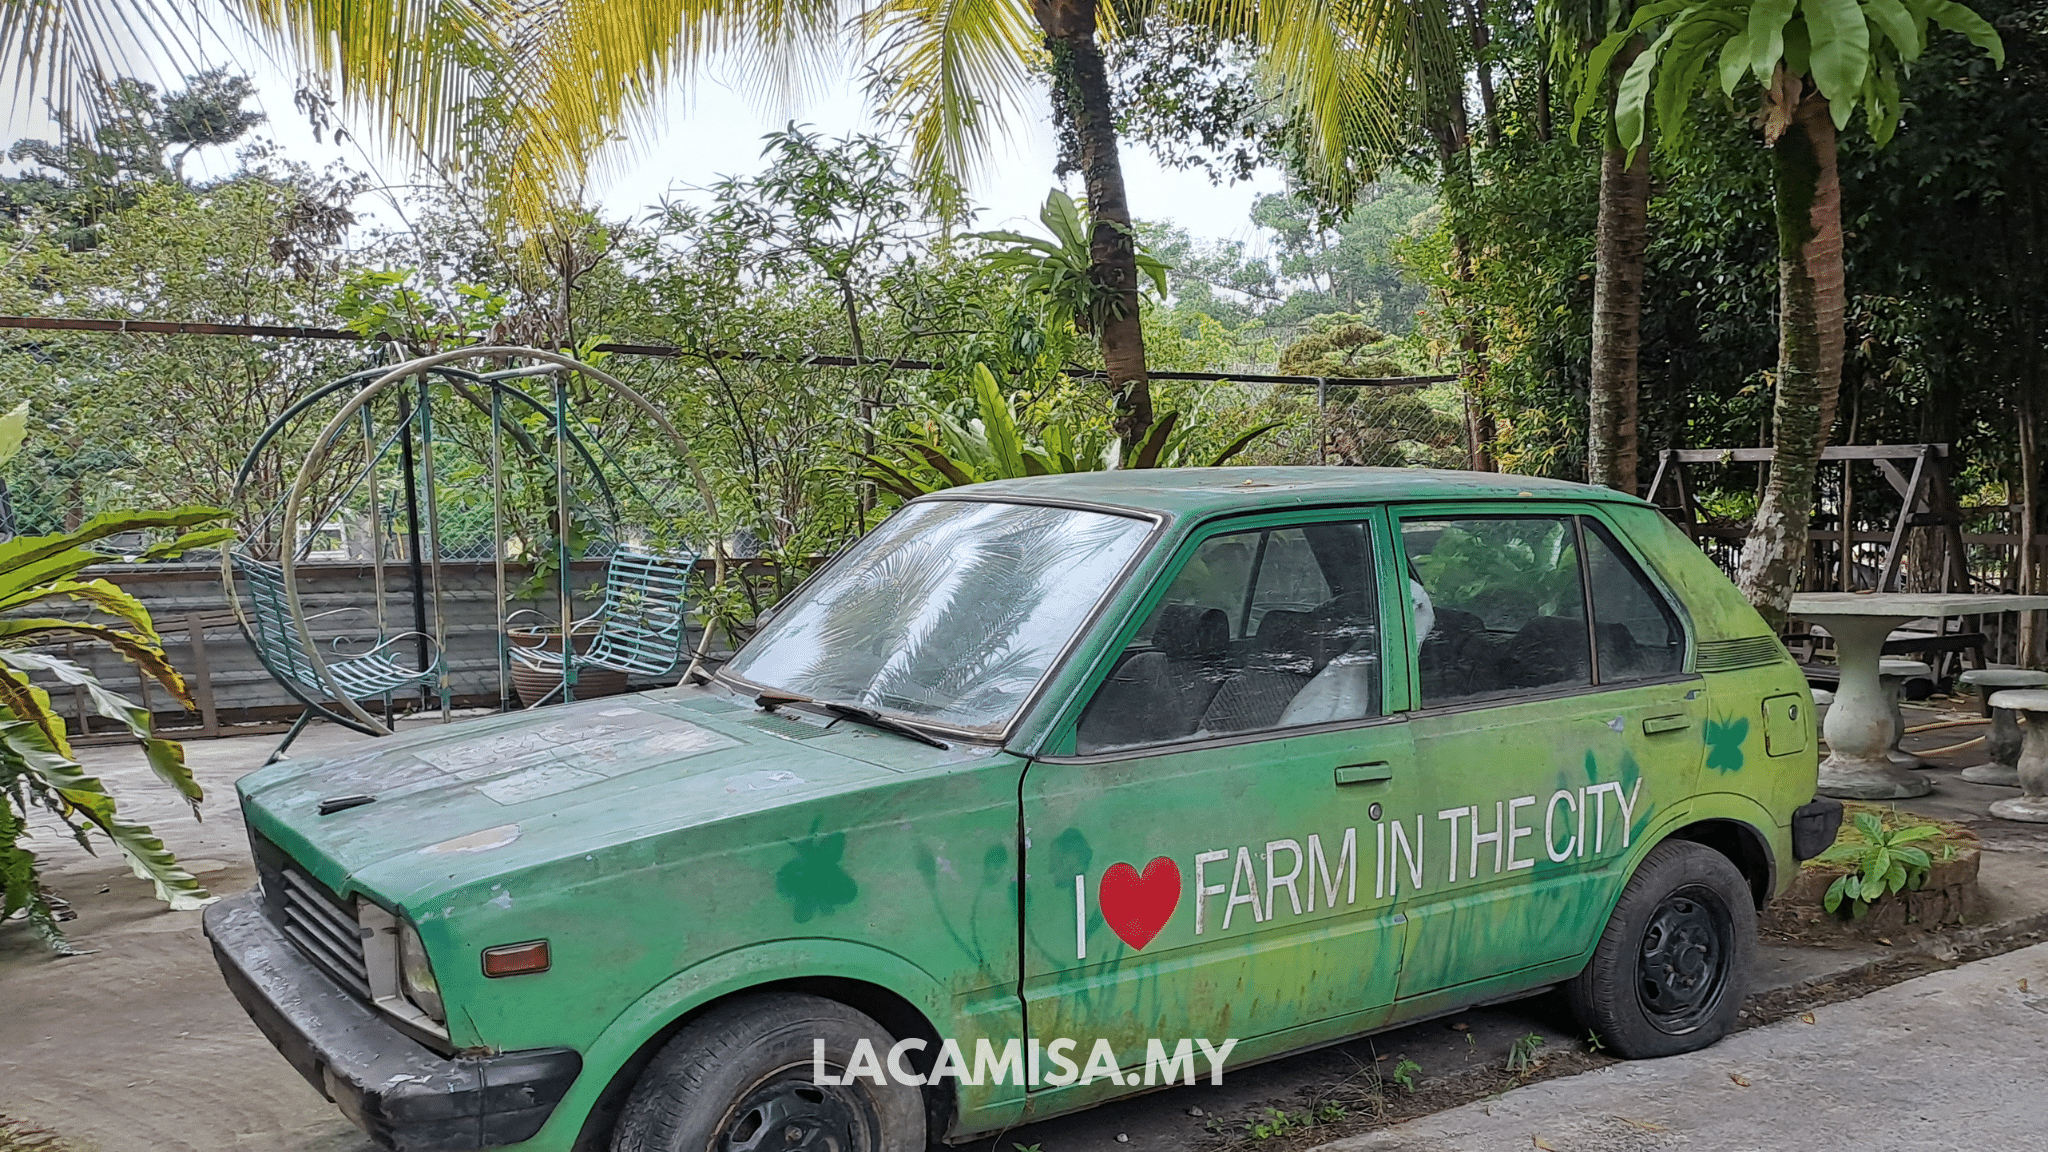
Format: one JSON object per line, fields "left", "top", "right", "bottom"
{"left": 1792, "top": 592, "right": 2048, "bottom": 804}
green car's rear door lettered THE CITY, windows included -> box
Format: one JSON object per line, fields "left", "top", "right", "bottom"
{"left": 1397, "top": 506, "right": 1706, "bottom": 1000}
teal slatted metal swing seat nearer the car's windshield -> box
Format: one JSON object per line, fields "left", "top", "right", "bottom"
{"left": 512, "top": 549, "right": 698, "bottom": 707}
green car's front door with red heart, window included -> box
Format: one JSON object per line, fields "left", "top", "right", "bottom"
{"left": 1022, "top": 512, "right": 1413, "bottom": 1107}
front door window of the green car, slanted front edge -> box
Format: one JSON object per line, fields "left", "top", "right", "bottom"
{"left": 1075, "top": 521, "right": 1380, "bottom": 756}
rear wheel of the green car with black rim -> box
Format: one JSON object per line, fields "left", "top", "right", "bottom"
{"left": 1565, "top": 828, "right": 1757, "bottom": 1060}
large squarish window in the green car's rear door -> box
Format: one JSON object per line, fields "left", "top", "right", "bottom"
{"left": 1401, "top": 517, "right": 1593, "bottom": 707}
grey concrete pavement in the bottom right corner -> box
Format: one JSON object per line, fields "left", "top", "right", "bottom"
{"left": 1317, "top": 945, "right": 2048, "bottom": 1152}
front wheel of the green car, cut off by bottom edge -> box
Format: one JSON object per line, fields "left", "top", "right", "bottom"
{"left": 612, "top": 994, "right": 926, "bottom": 1152}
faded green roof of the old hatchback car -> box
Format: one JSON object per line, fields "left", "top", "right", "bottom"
{"left": 946, "top": 465, "right": 1640, "bottom": 519}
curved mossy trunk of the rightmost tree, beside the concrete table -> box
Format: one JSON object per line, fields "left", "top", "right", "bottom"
{"left": 1737, "top": 92, "right": 1847, "bottom": 627}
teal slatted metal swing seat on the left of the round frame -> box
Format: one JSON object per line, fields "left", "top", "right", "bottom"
{"left": 231, "top": 553, "right": 442, "bottom": 765}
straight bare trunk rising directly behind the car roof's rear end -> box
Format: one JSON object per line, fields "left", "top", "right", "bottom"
{"left": 1585, "top": 37, "right": 1651, "bottom": 496}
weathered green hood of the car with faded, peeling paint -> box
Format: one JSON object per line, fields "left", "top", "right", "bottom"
{"left": 238, "top": 689, "right": 970, "bottom": 898}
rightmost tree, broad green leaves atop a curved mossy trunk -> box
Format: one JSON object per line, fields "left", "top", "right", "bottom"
{"left": 1585, "top": 0, "right": 2005, "bottom": 623}
